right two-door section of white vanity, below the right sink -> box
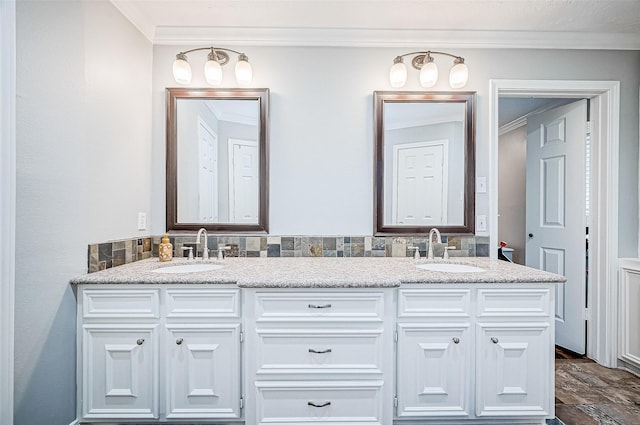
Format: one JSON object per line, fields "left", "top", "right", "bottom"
{"left": 396, "top": 284, "right": 555, "bottom": 424}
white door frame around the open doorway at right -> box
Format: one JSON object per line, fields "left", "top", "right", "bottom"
{"left": 489, "top": 80, "right": 620, "bottom": 367}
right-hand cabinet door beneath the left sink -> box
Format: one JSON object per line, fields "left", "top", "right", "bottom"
{"left": 166, "top": 323, "right": 241, "bottom": 419}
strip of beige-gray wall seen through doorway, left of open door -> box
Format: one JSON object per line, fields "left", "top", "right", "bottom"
{"left": 498, "top": 126, "right": 527, "bottom": 264}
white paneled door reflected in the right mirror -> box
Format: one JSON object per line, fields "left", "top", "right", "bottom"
{"left": 391, "top": 140, "right": 448, "bottom": 226}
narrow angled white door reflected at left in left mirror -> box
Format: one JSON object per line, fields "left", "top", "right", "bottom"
{"left": 198, "top": 120, "right": 218, "bottom": 223}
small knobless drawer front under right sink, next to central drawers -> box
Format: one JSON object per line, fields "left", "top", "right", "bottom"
{"left": 398, "top": 289, "right": 471, "bottom": 318}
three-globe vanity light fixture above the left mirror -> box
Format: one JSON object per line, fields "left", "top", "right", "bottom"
{"left": 173, "top": 46, "right": 253, "bottom": 86}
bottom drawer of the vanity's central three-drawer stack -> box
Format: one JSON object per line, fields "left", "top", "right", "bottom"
{"left": 256, "top": 381, "right": 382, "bottom": 425}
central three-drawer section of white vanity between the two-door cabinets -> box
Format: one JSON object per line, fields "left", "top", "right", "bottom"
{"left": 245, "top": 288, "right": 394, "bottom": 425}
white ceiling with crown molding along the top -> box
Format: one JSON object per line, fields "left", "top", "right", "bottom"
{"left": 111, "top": 0, "right": 640, "bottom": 50}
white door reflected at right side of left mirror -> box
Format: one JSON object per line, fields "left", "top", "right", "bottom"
{"left": 229, "top": 139, "right": 259, "bottom": 223}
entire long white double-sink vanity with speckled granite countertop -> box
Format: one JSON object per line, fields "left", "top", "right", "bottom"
{"left": 72, "top": 258, "right": 564, "bottom": 425}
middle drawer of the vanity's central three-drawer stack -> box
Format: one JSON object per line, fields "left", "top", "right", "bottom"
{"left": 256, "top": 329, "right": 382, "bottom": 375}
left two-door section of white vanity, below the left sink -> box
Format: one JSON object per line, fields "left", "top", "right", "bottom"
{"left": 78, "top": 285, "right": 242, "bottom": 423}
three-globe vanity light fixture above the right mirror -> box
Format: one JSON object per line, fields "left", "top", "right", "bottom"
{"left": 389, "top": 50, "right": 469, "bottom": 89}
